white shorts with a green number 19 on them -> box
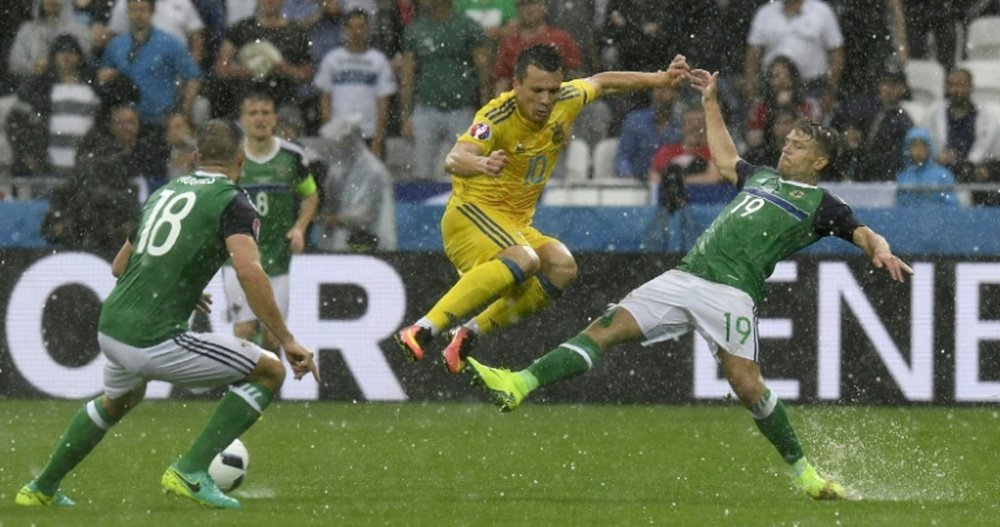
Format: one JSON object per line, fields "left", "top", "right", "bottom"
{"left": 617, "top": 269, "right": 758, "bottom": 361}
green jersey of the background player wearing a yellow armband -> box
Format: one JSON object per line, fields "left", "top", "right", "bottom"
{"left": 240, "top": 137, "right": 316, "bottom": 276}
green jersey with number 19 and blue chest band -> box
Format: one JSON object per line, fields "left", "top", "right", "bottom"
{"left": 677, "top": 160, "right": 863, "bottom": 304}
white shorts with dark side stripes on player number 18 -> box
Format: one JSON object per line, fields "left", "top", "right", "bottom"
{"left": 97, "top": 331, "right": 266, "bottom": 399}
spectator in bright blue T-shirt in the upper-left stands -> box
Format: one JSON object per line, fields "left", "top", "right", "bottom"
{"left": 97, "top": 0, "right": 201, "bottom": 126}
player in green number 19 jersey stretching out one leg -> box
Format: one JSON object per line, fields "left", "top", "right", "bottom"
{"left": 467, "top": 70, "right": 913, "bottom": 499}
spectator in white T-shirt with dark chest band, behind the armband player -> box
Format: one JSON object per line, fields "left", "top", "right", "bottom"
{"left": 313, "top": 9, "right": 396, "bottom": 158}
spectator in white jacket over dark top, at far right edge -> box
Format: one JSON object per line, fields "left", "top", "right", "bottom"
{"left": 924, "top": 68, "right": 1000, "bottom": 182}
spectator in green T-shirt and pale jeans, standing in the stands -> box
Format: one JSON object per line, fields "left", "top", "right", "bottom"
{"left": 399, "top": 0, "right": 491, "bottom": 179}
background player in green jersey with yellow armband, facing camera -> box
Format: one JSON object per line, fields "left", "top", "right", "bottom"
{"left": 222, "top": 92, "right": 319, "bottom": 352}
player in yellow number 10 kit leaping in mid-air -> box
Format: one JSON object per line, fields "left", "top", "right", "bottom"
{"left": 395, "top": 45, "right": 688, "bottom": 373}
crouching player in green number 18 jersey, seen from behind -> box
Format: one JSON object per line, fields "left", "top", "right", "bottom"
{"left": 14, "top": 120, "right": 319, "bottom": 509}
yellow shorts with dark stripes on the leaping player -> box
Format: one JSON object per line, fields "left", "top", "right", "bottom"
{"left": 441, "top": 199, "right": 559, "bottom": 274}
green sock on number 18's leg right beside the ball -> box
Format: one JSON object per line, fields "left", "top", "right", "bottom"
{"left": 177, "top": 381, "right": 274, "bottom": 472}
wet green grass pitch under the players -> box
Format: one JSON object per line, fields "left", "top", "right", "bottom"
{"left": 0, "top": 400, "right": 1000, "bottom": 527}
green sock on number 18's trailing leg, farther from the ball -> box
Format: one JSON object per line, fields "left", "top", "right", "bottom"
{"left": 35, "top": 398, "right": 118, "bottom": 496}
